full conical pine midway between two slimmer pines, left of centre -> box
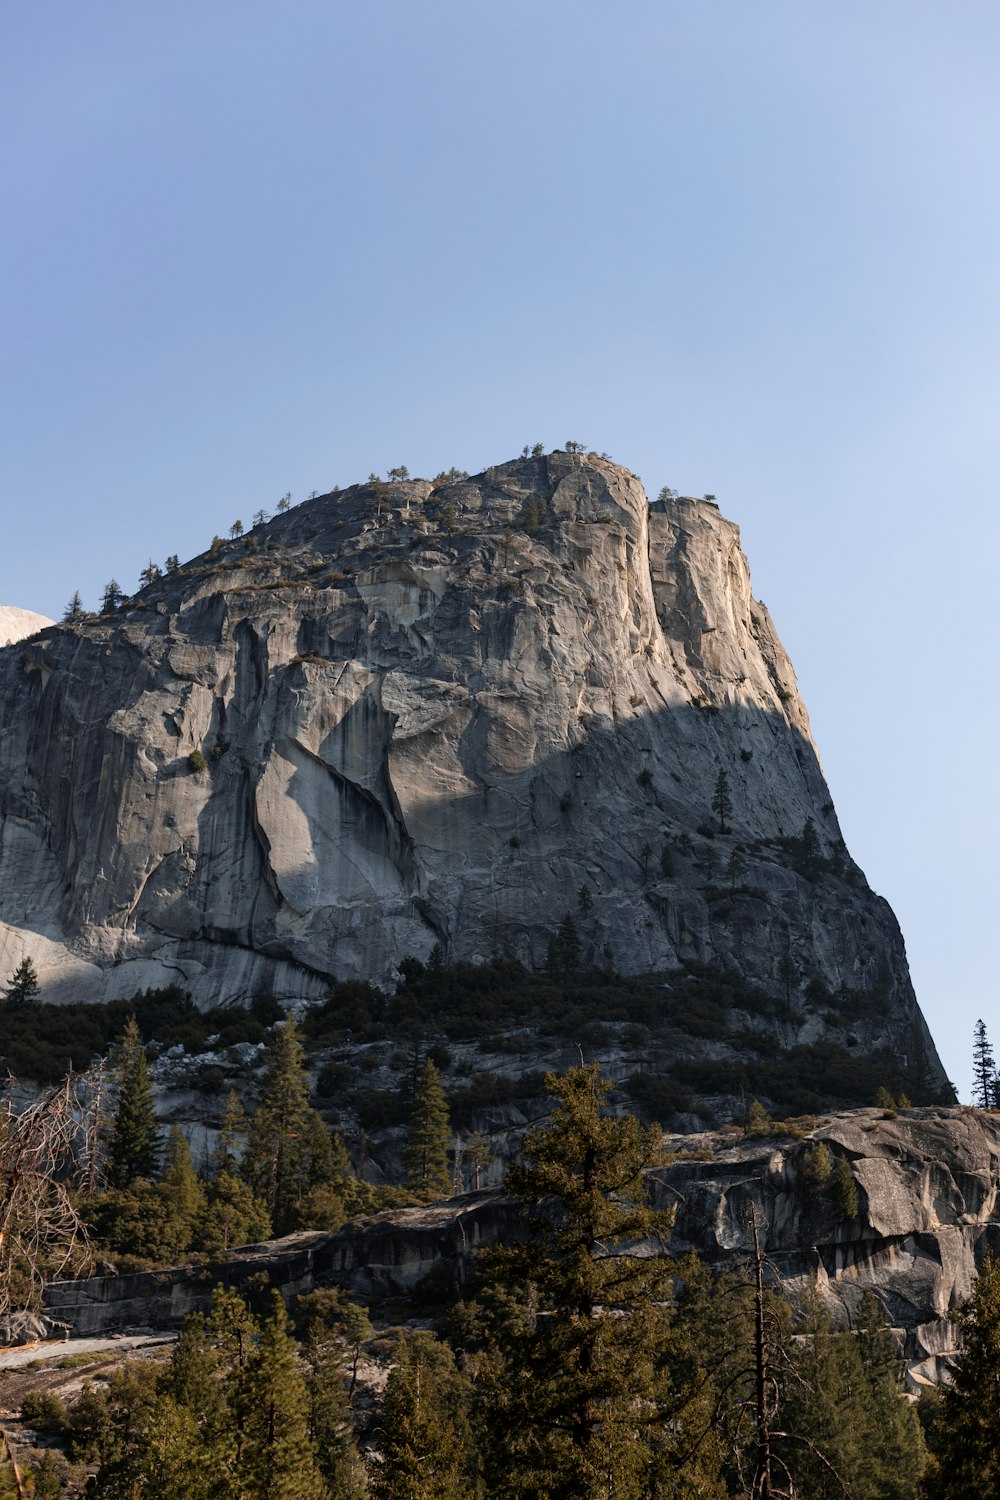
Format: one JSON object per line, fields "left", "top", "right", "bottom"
{"left": 241, "top": 1016, "right": 339, "bottom": 1235}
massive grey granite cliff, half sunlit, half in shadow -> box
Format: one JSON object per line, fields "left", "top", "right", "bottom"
{"left": 0, "top": 453, "right": 940, "bottom": 1079}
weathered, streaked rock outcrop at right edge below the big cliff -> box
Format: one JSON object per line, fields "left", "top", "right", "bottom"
{"left": 657, "top": 1109, "right": 1000, "bottom": 1385}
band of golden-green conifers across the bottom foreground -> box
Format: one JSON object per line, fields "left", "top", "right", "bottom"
{"left": 7, "top": 1062, "right": 1000, "bottom": 1500}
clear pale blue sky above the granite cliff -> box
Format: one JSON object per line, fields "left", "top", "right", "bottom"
{"left": 0, "top": 0, "right": 1000, "bottom": 1098}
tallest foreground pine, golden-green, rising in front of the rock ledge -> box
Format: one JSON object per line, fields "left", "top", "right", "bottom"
{"left": 480, "top": 1065, "right": 672, "bottom": 1500}
